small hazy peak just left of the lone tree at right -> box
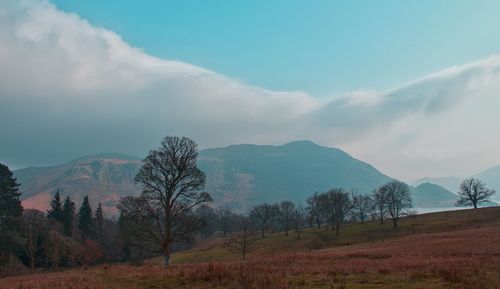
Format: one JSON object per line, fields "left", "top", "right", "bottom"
{"left": 412, "top": 183, "right": 457, "bottom": 208}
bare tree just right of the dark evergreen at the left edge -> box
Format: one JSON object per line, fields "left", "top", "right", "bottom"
{"left": 23, "top": 209, "right": 48, "bottom": 268}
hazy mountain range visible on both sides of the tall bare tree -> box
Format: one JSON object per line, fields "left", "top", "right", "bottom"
{"left": 14, "top": 141, "right": 392, "bottom": 214}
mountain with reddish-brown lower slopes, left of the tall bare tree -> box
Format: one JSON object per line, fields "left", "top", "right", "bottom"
{"left": 14, "top": 154, "right": 141, "bottom": 215}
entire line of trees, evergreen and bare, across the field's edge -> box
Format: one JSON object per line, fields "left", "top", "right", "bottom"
{"left": 0, "top": 137, "right": 495, "bottom": 274}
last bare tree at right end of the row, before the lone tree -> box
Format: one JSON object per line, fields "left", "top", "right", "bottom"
{"left": 380, "top": 181, "right": 413, "bottom": 228}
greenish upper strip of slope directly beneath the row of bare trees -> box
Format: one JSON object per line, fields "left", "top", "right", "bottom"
{"left": 171, "top": 207, "right": 500, "bottom": 264}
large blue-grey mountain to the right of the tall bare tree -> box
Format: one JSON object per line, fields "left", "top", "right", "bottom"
{"left": 199, "top": 141, "right": 392, "bottom": 209}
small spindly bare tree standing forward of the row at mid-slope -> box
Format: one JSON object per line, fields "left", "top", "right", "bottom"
{"left": 226, "top": 216, "right": 258, "bottom": 259}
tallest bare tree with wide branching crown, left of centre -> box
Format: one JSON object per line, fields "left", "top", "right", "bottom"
{"left": 119, "top": 137, "right": 212, "bottom": 267}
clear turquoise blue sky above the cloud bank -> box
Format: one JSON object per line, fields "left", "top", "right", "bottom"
{"left": 53, "top": 0, "right": 500, "bottom": 97}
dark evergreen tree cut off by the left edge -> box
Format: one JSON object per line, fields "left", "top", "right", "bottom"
{"left": 0, "top": 163, "right": 23, "bottom": 263}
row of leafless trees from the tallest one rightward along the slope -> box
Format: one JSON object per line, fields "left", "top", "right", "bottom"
{"left": 119, "top": 137, "right": 496, "bottom": 267}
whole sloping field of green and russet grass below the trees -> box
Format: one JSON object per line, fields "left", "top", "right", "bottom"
{"left": 0, "top": 208, "right": 500, "bottom": 289}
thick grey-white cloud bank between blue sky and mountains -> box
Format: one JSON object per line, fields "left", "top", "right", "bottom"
{"left": 0, "top": 0, "right": 500, "bottom": 180}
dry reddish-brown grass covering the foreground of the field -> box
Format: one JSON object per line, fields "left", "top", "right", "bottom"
{"left": 0, "top": 207, "right": 500, "bottom": 289}
